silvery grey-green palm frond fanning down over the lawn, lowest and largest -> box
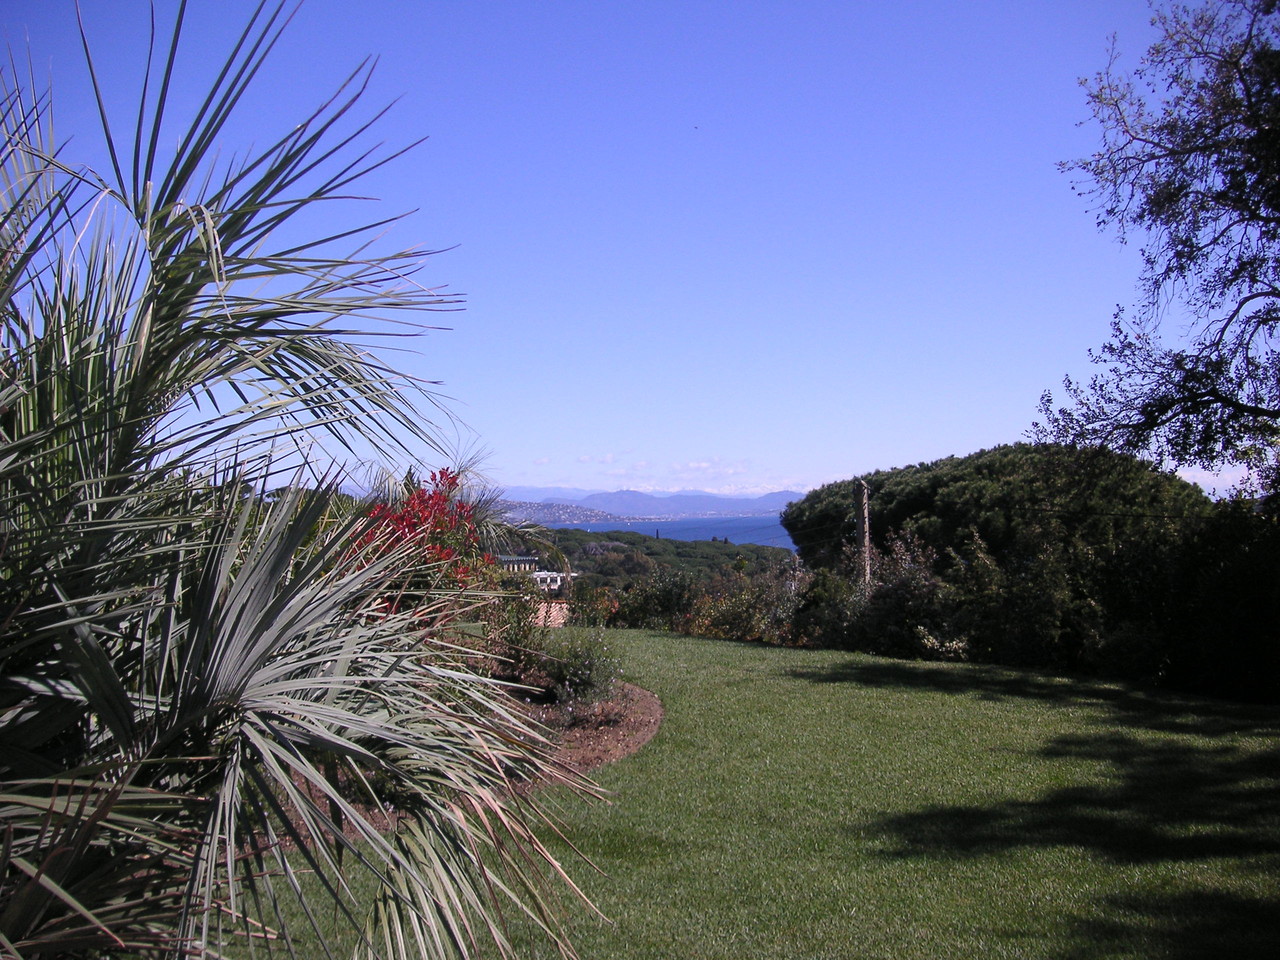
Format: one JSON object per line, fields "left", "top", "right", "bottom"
{"left": 160, "top": 483, "right": 593, "bottom": 956}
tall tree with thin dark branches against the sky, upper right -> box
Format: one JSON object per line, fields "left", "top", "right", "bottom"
{"left": 1042, "top": 0, "right": 1280, "bottom": 483}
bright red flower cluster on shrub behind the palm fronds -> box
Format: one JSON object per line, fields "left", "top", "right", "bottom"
{"left": 357, "top": 468, "right": 495, "bottom": 590}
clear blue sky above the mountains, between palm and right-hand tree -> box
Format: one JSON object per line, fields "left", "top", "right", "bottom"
{"left": 0, "top": 0, "right": 1198, "bottom": 494}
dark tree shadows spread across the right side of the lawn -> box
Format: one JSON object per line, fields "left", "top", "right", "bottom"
{"left": 794, "top": 660, "right": 1280, "bottom": 960}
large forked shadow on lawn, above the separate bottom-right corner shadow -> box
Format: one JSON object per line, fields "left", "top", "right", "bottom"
{"left": 805, "top": 660, "right": 1280, "bottom": 863}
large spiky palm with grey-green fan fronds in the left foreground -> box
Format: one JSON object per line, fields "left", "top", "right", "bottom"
{"left": 0, "top": 0, "right": 585, "bottom": 957}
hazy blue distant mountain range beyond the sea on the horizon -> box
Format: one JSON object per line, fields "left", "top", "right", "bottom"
{"left": 496, "top": 486, "right": 804, "bottom": 524}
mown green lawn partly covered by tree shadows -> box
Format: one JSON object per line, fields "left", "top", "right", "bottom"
{"left": 491, "top": 631, "right": 1280, "bottom": 960}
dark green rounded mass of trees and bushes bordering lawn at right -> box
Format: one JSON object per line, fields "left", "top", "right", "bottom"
{"left": 782, "top": 444, "right": 1280, "bottom": 698}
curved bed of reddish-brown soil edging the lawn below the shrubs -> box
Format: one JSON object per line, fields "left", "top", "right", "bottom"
{"left": 524, "top": 681, "right": 662, "bottom": 773}
